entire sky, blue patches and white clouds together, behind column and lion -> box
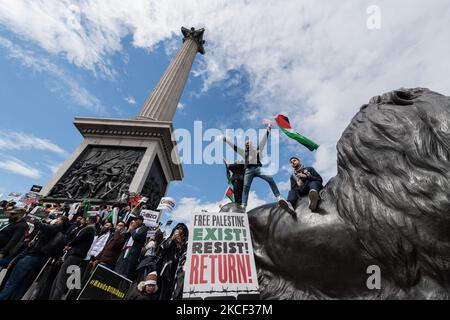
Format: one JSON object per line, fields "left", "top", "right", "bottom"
{"left": 0, "top": 0, "right": 450, "bottom": 224}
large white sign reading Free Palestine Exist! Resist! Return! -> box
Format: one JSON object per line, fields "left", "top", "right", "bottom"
{"left": 183, "top": 212, "right": 259, "bottom": 300}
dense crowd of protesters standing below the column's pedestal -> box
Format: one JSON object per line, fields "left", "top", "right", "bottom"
{"left": 0, "top": 201, "right": 188, "bottom": 300}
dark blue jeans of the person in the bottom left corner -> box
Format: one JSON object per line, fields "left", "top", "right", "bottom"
{"left": 0, "top": 255, "right": 46, "bottom": 300}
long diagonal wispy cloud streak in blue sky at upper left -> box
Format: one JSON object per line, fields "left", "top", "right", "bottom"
{"left": 0, "top": 36, "right": 105, "bottom": 113}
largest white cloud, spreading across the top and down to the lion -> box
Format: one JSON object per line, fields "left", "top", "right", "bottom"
{"left": 0, "top": 0, "right": 450, "bottom": 178}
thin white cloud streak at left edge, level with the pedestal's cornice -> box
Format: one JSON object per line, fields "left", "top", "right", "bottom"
{"left": 0, "top": 130, "right": 67, "bottom": 156}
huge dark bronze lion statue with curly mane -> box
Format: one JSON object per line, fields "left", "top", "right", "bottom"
{"left": 223, "top": 88, "right": 450, "bottom": 299}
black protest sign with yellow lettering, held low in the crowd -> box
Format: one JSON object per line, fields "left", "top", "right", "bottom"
{"left": 77, "top": 264, "right": 132, "bottom": 300}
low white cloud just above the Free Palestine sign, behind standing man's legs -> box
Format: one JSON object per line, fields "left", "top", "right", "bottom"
{"left": 170, "top": 191, "right": 266, "bottom": 225}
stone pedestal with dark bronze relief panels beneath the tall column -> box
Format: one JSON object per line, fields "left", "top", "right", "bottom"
{"left": 41, "top": 118, "right": 183, "bottom": 209}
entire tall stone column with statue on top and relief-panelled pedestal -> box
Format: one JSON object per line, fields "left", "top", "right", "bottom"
{"left": 41, "top": 27, "right": 205, "bottom": 209}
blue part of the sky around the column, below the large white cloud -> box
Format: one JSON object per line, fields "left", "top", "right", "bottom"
{"left": 0, "top": 13, "right": 311, "bottom": 222}
